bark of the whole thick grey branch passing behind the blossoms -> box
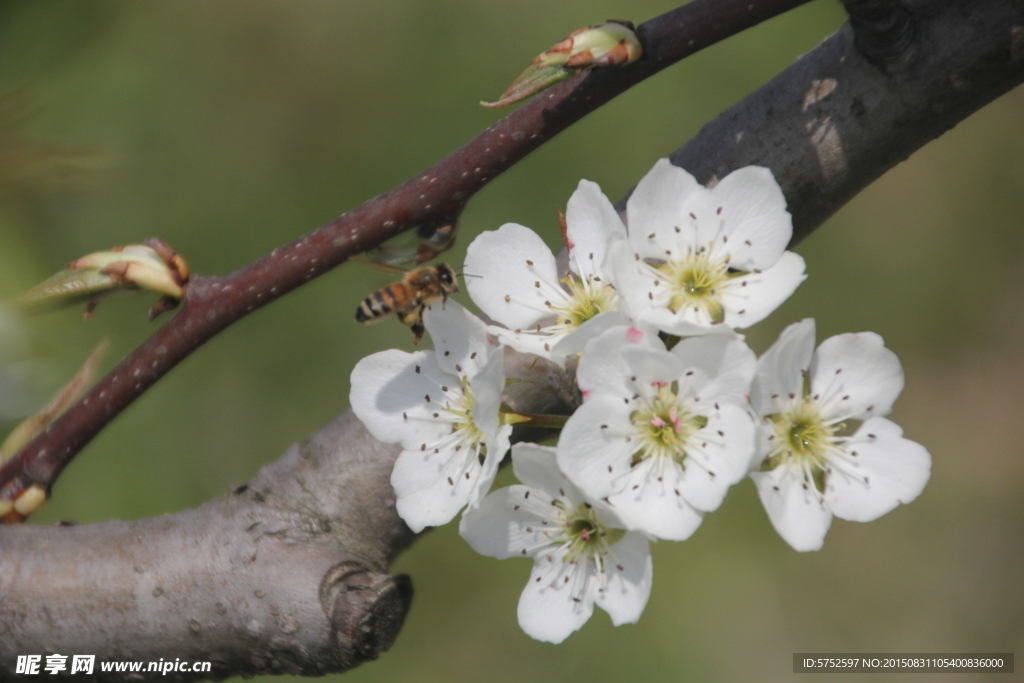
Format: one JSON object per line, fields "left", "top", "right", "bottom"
{"left": 0, "top": 0, "right": 1024, "bottom": 680}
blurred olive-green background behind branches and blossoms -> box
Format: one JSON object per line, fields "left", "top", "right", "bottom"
{"left": 0, "top": 0, "right": 1024, "bottom": 682}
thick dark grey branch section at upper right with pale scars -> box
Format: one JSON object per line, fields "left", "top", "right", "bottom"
{"left": 671, "top": 0, "right": 1024, "bottom": 242}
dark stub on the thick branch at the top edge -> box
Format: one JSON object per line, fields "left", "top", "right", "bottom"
{"left": 843, "top": 0, "right": 916, "bottom": 71}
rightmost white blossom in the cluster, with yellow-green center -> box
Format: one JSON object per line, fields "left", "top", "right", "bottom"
{"left": 751, "top": 318, "right": 932, "bottom": 551}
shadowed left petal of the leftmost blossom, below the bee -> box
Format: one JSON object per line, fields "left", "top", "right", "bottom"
{"left": 348, "top": 349, "right": 455, "bottom": 449}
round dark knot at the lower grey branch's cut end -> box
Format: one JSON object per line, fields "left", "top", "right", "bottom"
{"left": 319, "top": 561, "right": 413, "bottom": 671}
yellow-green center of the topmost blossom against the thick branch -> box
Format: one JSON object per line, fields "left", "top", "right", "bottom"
{"left": 654, "top": 249, "right": 746, "bottom": 323}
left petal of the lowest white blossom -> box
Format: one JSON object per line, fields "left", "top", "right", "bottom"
{"left": 459, "top": 483, "right": 554, "bottom": 560}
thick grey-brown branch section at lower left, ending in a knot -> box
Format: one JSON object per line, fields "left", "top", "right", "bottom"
{"left": 0, "top": 413, "right": 412, "bottom": 680}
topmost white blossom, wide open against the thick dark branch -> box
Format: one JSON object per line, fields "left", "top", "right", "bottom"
{"left": 609, "top": 159, "right": 805, "bottom": 335}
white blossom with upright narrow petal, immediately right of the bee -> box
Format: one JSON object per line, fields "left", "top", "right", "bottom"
{"left": 464, "top": 180, "right": 629, "bottom": 360}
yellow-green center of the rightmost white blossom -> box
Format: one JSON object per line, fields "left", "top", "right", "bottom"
{"left": 761, "top": 397, "right": 842, "bottom": 492}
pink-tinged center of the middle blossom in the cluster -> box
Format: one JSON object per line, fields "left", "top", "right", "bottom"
{"left": 630, "top": 384, "right": 708, "bottom": 466}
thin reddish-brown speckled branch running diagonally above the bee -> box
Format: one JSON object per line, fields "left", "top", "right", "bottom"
{"left": 0, "top": 0, "right": 809, "bottom": 521}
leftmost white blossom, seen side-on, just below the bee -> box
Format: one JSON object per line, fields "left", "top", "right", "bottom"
{"left": 349, "top": 300, "right": 512, "bottom": 531}
